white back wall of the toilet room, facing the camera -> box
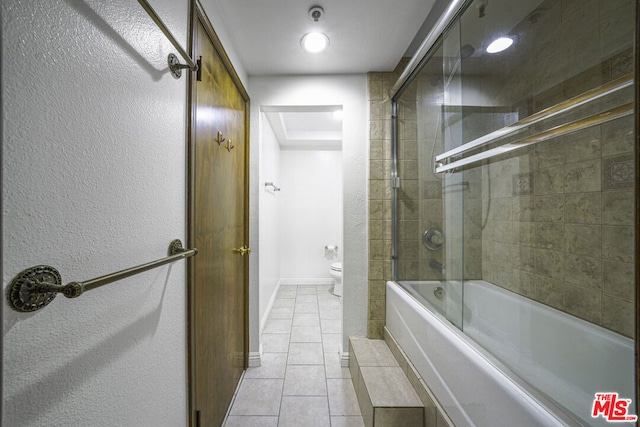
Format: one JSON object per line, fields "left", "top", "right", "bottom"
{"left": 279, "top": 150, "right": 343, "bottom": 284}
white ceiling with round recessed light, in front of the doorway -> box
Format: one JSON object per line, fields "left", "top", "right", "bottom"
{"left": 212, "top": 0, "right": 435, "bottom": 75}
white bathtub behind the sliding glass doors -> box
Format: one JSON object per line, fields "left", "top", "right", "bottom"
{"left": 386, "top": 281, "right": 636, "bottom": 427}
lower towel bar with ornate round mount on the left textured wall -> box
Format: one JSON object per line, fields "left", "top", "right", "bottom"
{"left": 6, "top": 239, "right": 198, "bottom": 313}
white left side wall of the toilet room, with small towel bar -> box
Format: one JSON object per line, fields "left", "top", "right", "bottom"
{"left": 257, "top": 113, "right": 282, "bottom": 330}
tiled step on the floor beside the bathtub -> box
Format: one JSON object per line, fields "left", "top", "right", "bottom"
{"left": 349, "top": 338, "right": 424, "bottom": 427}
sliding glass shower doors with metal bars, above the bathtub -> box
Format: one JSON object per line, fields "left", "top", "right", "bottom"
{"left": 394, "top": 0, "right": 637, "bottom": 422}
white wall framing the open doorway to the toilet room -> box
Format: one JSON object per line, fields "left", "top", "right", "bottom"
{"left": 249, "top": 74, "right": 369, "bottom": 357}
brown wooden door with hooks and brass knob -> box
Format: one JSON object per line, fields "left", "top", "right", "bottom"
{"left": 189, "top": 4, "right": 249, "bottom": 427}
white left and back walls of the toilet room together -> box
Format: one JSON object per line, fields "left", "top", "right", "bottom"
{"left": 258, "top": 119, "right": 343, "bottom": 330}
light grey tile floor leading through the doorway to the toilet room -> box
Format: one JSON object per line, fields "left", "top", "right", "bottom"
{"left": 225, "top": 285, "right": 364, "bottom": 427}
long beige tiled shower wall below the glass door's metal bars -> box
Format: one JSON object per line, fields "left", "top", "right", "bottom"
{"left": 482, "top": 113, "right": 634, "bottom": 336}
